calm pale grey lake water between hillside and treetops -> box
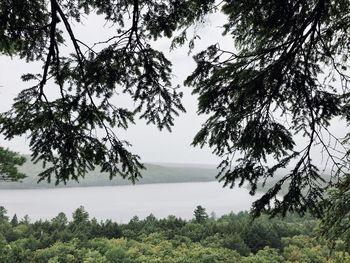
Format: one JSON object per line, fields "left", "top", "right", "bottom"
{"left": 0, "top": 182, "right": 257, "bottom": 222}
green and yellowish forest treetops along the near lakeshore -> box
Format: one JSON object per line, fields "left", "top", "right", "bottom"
{"left": 0, "top": 206, "right": 350, "bottom": 263}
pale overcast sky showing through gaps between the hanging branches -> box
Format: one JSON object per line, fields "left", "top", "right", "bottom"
{"left": 0, "top": 12, "right": 231, "bottom": 164}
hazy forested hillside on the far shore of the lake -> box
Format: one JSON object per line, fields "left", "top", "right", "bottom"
{"left": 0, "top": 157, "right": 217, "bottom": 189}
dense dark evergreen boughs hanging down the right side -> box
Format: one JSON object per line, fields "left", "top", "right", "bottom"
{"left": 186, "top": 0, "right": 350, "bottom": 219}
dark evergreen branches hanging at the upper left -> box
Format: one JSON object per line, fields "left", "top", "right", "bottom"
{"left": 0, "top": 0, "right": 205, "bottom": 184}
